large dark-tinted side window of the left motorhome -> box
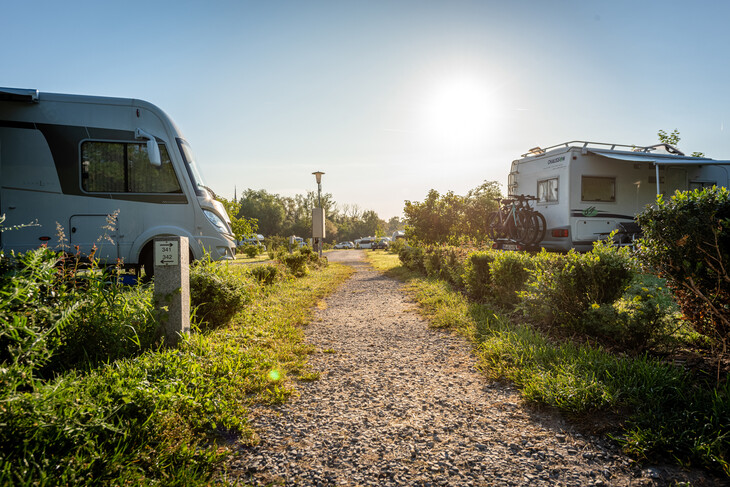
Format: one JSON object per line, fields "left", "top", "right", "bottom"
{"left": 81, "top": 141, "right": 182, "bottom": 193}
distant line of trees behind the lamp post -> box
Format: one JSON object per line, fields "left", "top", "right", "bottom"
{"left": 231, "top": 188, "right": 405, "bottom": 243}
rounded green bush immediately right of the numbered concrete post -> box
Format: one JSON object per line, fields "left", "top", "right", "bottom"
{"left": 190, "top": 260, "right": 255, "bottom": 328}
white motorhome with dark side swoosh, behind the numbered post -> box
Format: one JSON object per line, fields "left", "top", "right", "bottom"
{"left": 0, "top": 88, "right": 235, "bottom": 272}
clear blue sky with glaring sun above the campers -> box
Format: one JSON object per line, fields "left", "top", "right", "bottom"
{"left": 0, "top": 0, "right": 730, "bottom": 220}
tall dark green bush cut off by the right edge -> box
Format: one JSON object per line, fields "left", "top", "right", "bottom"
{"left": 637, "top": 188, "right": 730, "bottom": 340}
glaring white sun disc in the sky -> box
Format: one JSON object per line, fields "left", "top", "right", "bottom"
{"left": 424, "top": 77, "right": 496, "bottom": 148}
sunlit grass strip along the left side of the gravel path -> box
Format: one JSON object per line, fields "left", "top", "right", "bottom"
{"left": 0, "top": 264, "right": 353, "bottom": 485}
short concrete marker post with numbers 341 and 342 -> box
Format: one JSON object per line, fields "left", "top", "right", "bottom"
{"left": 154, "top": 236, "right": 190, "bottom": 347}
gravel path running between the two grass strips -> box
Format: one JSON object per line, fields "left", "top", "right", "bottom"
{"left": 228, "top": 251, "right": 716, "bottom": 486}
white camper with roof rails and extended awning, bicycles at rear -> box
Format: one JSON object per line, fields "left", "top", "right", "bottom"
{"left": 508, "top": 141, "right": 730, "bottom": 251}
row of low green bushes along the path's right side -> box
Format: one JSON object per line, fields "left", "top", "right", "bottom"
{"left": 399, "top": 240, "right": 676, "bottom": 352}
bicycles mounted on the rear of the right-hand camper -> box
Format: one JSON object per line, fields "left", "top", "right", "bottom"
{"left": 487, "top": 195, "right": 546, "bottom": 247}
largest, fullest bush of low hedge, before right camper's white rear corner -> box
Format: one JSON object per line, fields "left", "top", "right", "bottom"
{"left": 520, "top": 240, "right": 636, "bottom": 331}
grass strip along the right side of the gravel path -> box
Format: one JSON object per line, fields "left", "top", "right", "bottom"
{"left": 368, "top": 253, "right": 730, "bottom": 476}
